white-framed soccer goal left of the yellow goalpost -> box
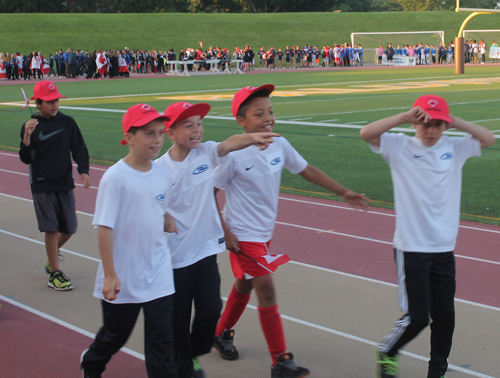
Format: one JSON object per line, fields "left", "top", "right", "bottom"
{"left": 351, "top": 31, "right": 445, "bottom": 63}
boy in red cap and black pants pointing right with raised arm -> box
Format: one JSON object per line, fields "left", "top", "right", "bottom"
{"left": 156, "top": 102, "right": 279, "bottom": 378}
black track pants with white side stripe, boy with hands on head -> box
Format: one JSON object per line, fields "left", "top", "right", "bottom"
{"left": 380, "top": 250, "right": 456, "bottom": 378}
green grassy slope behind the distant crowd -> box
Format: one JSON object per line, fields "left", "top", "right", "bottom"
{"left": 0, "top": 11, "right": 500, "bottom": 56}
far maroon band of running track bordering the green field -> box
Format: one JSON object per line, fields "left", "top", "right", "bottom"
{"left": 0, "top": 152, "right": 500, "bottom": 307}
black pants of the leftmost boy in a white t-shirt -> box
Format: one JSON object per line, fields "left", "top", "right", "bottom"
{"left": 81, "top": 295, "right": 178, "bottom": 378}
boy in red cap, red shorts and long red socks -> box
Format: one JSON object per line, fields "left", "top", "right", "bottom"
{"left": 214, "top": 84, "right": 369, "bottom": 378}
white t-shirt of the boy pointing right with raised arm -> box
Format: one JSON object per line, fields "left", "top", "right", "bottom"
{"left": 155, "top": 142, "right": 226, "bottom": 269}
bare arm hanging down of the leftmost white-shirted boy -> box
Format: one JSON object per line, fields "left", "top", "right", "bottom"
{"left": 97, "top": 226, "right": 122, "bottom": 301}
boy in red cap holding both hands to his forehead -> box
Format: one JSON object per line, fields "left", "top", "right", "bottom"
{"left": 361, "top": 95, "right": 495, "bottom": 378}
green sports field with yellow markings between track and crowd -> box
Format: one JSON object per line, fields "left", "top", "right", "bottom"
{"left": 0, "top": 66, "right": 500, "bottom": 224}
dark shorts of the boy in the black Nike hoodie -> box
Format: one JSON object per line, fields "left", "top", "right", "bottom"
{"left": 33, "top": 189, "right": 78, "bottom": 235}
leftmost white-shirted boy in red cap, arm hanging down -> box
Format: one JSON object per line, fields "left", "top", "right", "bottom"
{"left": 81, "top": 104, "right": 178, "bottom": 378}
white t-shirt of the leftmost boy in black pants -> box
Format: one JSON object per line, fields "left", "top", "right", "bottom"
{"left": 92, "top": 160, "right": 175, "bottom": 303}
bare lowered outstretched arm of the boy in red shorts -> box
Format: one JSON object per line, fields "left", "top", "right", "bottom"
{"left": 299, "top": 164, "right": 371, "bottom": 210}
